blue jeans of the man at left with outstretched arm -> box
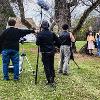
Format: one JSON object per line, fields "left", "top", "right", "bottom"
{"left": 2, "top": 49, "right": 19, "bottom": 80}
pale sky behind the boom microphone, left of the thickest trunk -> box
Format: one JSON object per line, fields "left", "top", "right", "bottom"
{"left": 24, "top": 0, "right": 53, "bottom": 24}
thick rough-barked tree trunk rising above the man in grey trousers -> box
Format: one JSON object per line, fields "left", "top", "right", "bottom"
{"left": 55, "top": 0, "right": 71, "bottom": 31}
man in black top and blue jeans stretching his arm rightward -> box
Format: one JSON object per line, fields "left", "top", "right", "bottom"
{"left": 0, "top": 19, "right": 35, "bottom": 80}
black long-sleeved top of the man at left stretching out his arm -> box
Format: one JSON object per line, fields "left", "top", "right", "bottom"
{"left": 0, "top": 27, "right": 34, "bottom": 51}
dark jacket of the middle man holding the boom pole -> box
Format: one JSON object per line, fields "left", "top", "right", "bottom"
{"left": 36, "top": 29, "right": 61, "bottom": 53}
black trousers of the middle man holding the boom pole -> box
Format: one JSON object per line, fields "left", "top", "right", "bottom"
{"left": 42, "top": 53, "right": 55, "bottom": 83}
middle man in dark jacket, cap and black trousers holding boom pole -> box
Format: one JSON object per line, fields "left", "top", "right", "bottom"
{"left": 36, "top": 21, "right": 60, "bottom": 84}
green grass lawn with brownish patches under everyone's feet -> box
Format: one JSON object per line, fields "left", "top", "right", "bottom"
{"left": 0, "top": 42, "right": 100, "bottom": 100}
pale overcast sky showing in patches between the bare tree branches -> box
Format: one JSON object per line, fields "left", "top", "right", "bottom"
{"left": 12, "top": 0, "right": 99, "bottom": 25}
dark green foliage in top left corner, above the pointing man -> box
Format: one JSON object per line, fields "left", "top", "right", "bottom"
{"left": 0, "top": 0, "right": 15, "bottom": 31}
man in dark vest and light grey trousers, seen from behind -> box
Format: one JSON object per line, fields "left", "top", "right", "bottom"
{"left": 58, "top": 24, "right": 75, "bottom": 75}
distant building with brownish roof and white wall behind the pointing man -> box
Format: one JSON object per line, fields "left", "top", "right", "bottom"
{"left": 6, "top": 17, "right": 37, "bottom": 42}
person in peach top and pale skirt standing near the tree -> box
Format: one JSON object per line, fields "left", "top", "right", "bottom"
{"left": 87, "top": 32, "right": 95, "bottom": 56}
